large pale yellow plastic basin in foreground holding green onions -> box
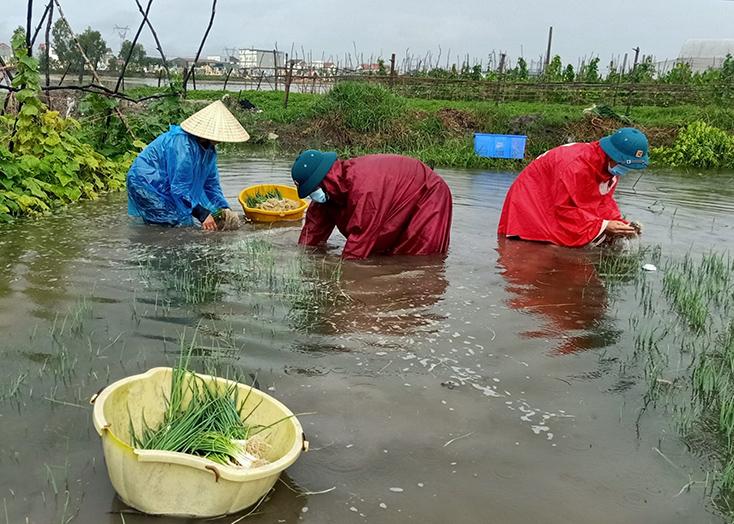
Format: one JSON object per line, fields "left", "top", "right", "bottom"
{"left": 93, "top": 368, "right": 307, "bottom": 518}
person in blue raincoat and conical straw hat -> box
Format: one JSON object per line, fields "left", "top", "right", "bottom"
{"left": 127, "top": 101, "right": 250, "bottom": 231}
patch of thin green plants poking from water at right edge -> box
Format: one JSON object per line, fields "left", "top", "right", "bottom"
{"left": 625, "top": 251, "right": 734, "bottom": 508}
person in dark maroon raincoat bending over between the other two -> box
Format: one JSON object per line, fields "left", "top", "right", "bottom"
{"left": 291, "top": 149, "right": 452, "bottom": 259}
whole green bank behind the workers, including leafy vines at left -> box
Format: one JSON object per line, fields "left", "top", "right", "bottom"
{"left": 0, "top": 64, "right": 734, "bottom": 221}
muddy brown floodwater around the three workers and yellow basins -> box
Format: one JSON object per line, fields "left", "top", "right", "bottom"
{"left": 0, "top": 159, "right": 734, "bottom": 524}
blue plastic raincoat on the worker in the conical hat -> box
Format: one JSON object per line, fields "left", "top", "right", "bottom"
{"left": 127, "top": 126, "right": 229, "bottom": 226}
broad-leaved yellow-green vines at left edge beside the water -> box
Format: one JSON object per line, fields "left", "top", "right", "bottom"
{"left": 0, "top": 34, "right": 126, "bottom": 222}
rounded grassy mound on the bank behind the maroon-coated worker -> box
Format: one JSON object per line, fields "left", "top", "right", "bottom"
{"left": 317, "top": 82, "right": 405, "bottom": 133}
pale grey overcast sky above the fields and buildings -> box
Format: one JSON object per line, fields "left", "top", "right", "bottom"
{"left": 0, "top": 0, "right": 734, "bottom": 65}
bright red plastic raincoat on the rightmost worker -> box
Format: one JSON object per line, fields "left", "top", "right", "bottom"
{"left": 497, "top": 142, "right": 622, "bottom": 247}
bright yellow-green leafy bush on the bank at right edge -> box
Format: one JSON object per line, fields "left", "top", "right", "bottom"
{"left": 653, "top": 121, "right": 734, "bottom": 169}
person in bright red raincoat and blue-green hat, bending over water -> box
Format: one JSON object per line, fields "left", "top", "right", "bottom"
{"left": 497, "top": 128, "right": 649, "bottom": 247}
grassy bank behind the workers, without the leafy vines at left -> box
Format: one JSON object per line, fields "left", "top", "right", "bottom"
{"left": 106, "top": 83, "right": 734, "bottom": 169}
